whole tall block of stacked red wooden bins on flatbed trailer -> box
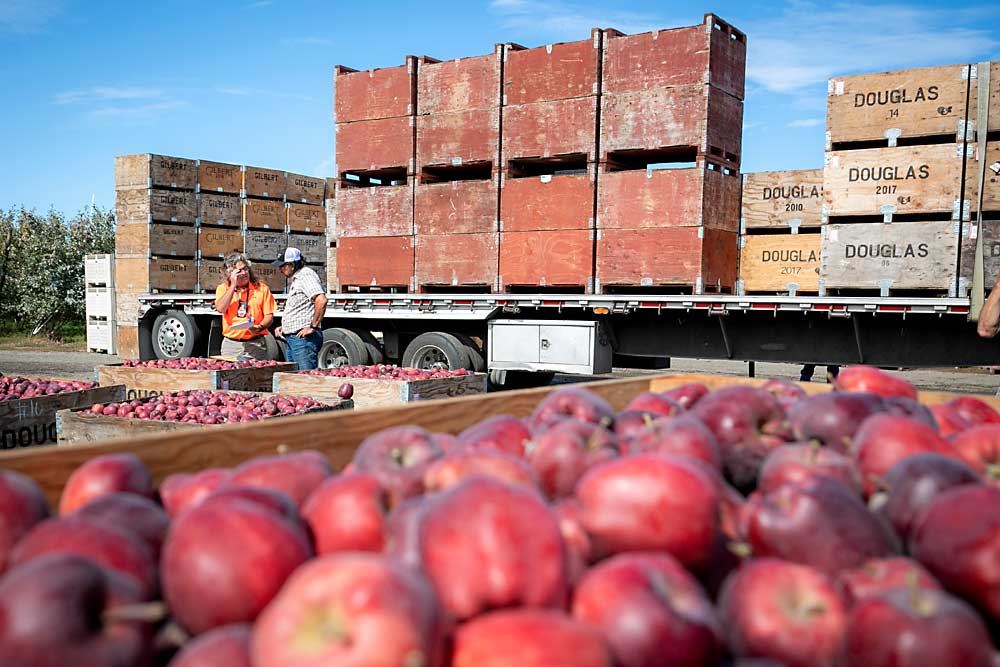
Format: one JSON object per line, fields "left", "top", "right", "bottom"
{"left": 334, "top": 14, "right": 746, "bottom": 293}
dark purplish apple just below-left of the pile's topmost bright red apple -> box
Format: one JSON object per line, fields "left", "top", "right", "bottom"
{"left": 788, "top": 391, "right": 884, "bottom": 453}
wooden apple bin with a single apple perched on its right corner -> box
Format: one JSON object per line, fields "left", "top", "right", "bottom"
{"left": 56, "top": 389, "right": 354, "bottom": 445}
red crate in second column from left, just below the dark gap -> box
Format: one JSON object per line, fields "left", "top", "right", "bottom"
{"left": 413, "top": 174, "right": 500, "bottom": 237}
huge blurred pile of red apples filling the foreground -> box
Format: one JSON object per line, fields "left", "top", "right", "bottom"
{"left": 0, "top": 367, "right": 1000, "bottom": 667}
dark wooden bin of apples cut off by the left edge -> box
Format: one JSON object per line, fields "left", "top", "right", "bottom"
{"left": 0, "top": 373, "right": 125, "bottom": 450}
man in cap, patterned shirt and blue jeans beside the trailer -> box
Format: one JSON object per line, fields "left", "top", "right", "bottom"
{"left": 271, "top": 248, "right": 327, "bottom": 371}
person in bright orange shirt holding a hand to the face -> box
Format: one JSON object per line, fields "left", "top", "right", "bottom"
{"left": 215, "top": 252, "right": 279, "bottom": 360}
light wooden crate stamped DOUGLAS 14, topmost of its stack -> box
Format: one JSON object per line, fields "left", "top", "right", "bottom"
{"left": 826, "top": 65, "right": 969, "bottom": 150}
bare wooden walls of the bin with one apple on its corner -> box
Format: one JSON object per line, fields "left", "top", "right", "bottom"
{"left": 55, "top": 392, "right": 353, "bottom": 445}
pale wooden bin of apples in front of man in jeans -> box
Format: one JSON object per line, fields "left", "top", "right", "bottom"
{"left": 271, "top": 364, "right": 486, "bottom": 408}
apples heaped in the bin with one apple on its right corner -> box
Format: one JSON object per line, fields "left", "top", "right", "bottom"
{"left": 82, "top": 389, "right": 329, "bottom": 424}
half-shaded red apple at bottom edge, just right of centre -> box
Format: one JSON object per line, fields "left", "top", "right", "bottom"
{"left": 573, "top": 553, "right": 721, "bottom": 667}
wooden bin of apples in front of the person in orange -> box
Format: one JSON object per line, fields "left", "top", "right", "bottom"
{"left": 94, "top": 357, "right": 296, "bottom": 401}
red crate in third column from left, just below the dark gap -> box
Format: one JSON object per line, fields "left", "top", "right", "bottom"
{"left": 499, "top": 164, "right": 597, "bottom": 232}
